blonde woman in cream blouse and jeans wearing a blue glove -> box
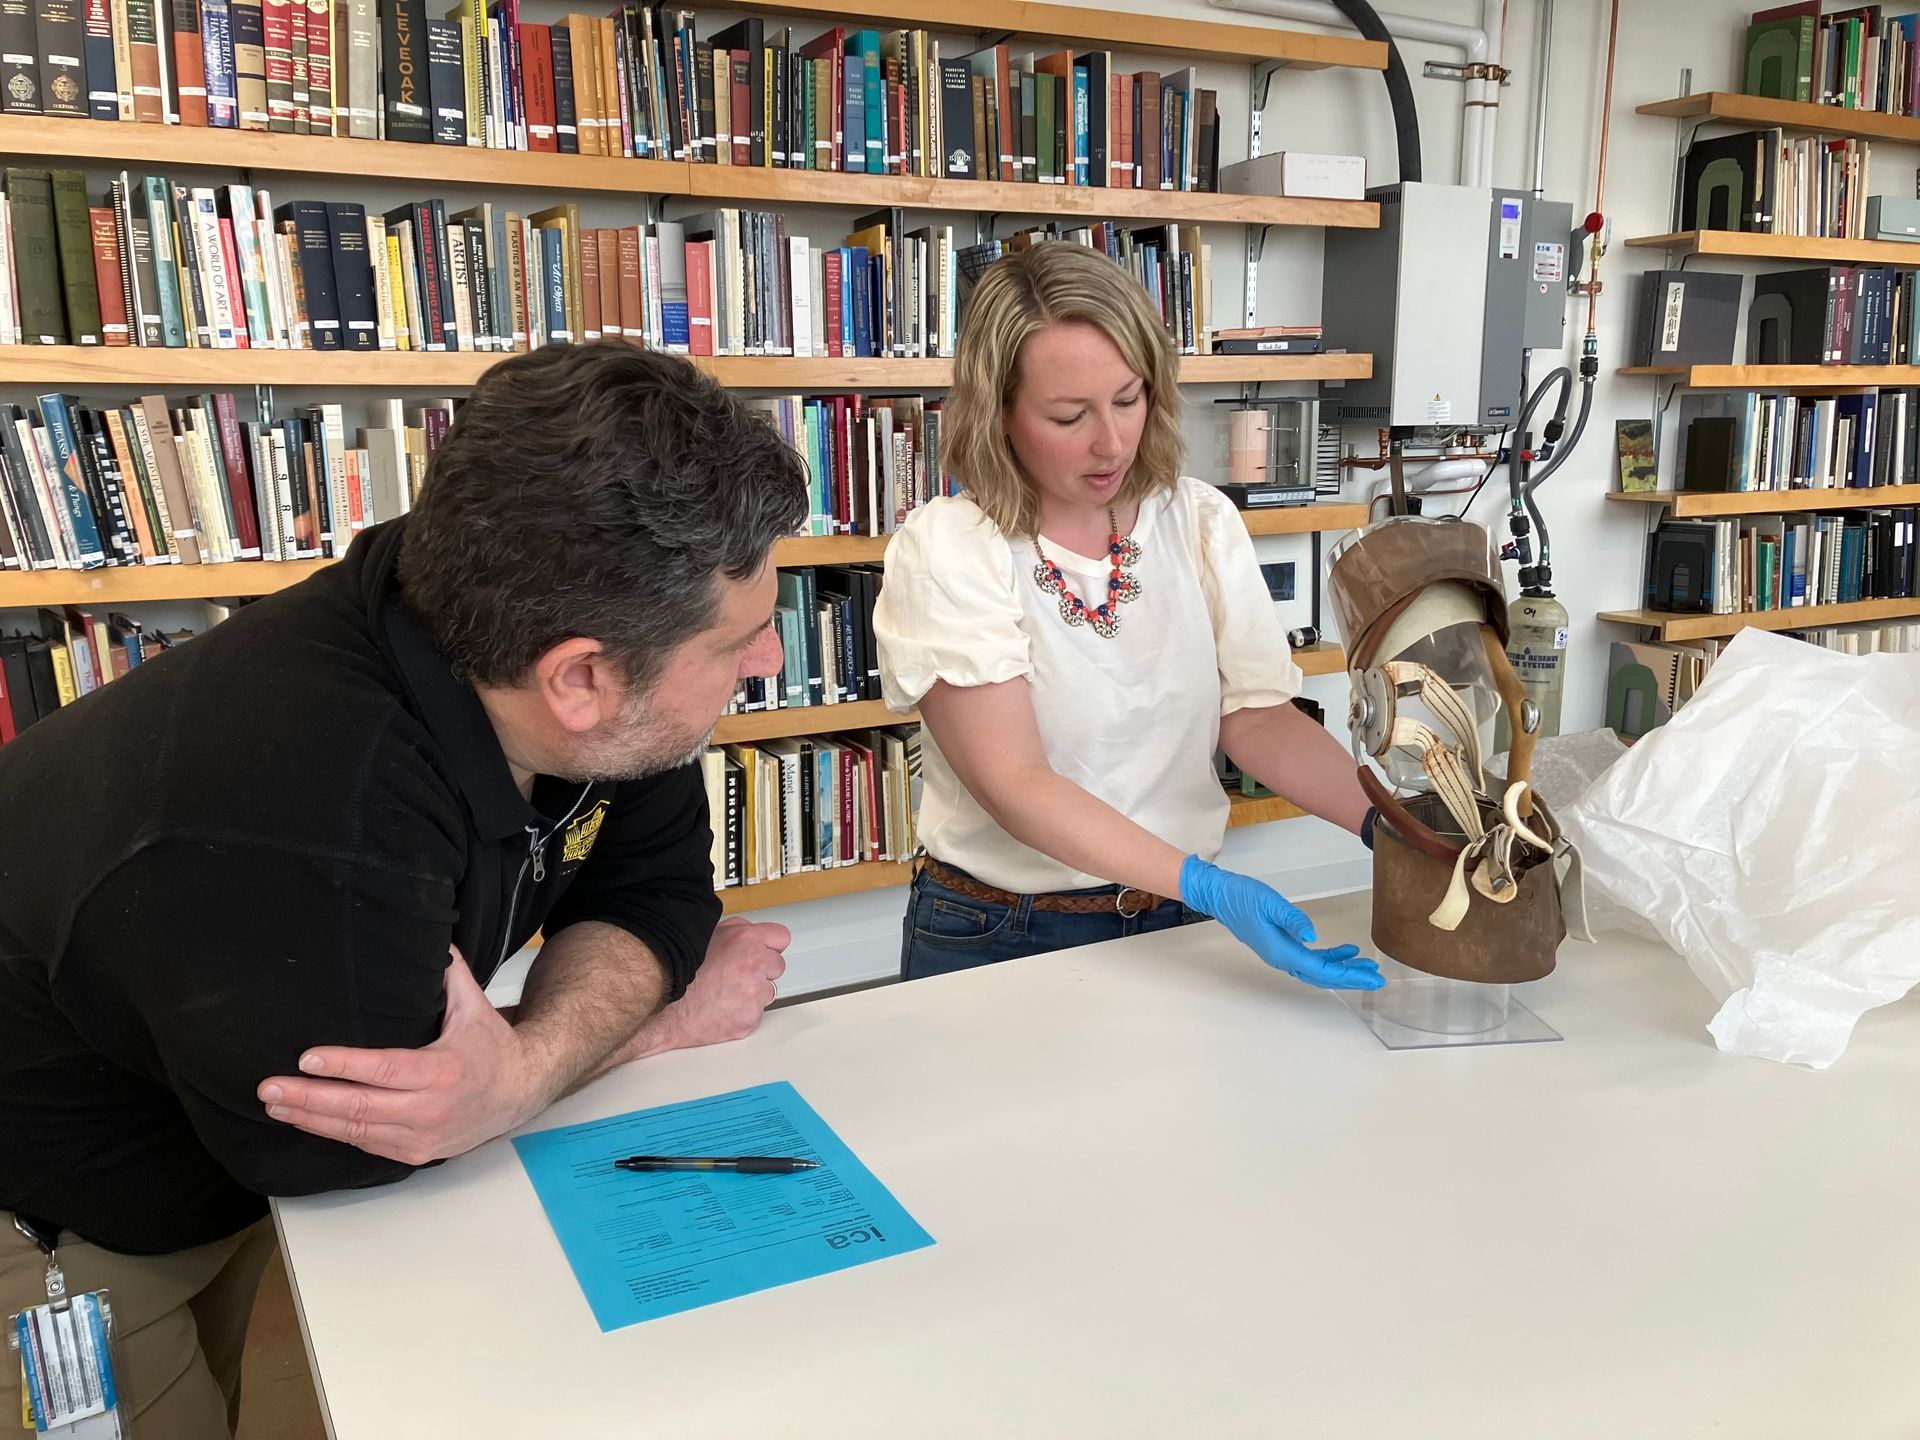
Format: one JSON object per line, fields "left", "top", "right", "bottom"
{"left": 874, "top": 242, "right": 1380, "bottom": 989}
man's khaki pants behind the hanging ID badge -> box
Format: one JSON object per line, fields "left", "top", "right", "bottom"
{"left": 0, "top": 1210, "right": 273, "bottom": 1440}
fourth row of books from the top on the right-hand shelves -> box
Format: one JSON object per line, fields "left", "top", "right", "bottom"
{"left": 1674, "top": 390, "right": 1920, "bottom": 492}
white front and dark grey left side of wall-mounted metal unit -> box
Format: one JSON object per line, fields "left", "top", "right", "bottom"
{"left": 1321, "top": 180, "right": 1519, "bottom": 428}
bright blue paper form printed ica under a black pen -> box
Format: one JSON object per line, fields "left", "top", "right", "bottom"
{"left": 513, "top": 1081, "right": 933, "bottom": 1331}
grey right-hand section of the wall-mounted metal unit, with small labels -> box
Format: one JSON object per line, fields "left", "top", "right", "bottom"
{"left": 1480, "top": 190, "right": 1578, "bottom": 426}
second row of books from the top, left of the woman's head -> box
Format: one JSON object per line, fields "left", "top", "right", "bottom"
{"left": 0, "top": 169, "right": 975, "bottom": 357}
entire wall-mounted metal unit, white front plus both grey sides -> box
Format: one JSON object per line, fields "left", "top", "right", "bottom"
{"left": 1321, "top": 180, "right": 1572, "bottom": 430}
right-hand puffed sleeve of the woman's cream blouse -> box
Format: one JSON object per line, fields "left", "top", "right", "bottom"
{"left": 1181, "top": 480, "right": 1302, "bottom": 716}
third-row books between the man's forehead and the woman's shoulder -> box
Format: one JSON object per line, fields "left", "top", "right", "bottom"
{"left": 749, "top": 394, "right": 958, "bottom": 536}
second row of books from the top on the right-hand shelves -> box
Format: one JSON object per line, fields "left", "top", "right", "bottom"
{"left": 1680, "top": 129, "right": 1872, "bottom": 240}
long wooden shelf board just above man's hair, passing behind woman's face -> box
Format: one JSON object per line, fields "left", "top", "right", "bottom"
{"left": 0, "top": 346, "right": 1373, "bottom": 390}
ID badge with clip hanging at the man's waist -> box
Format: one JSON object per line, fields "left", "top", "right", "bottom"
{"left": 0, "top": 1225, "right": 129, "bottom": 1440}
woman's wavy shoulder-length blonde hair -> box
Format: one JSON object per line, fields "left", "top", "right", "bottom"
{"left": 943, "top": 240, "right": 1185, "bottom": 536}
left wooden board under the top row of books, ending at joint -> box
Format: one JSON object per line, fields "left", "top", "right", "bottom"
{"left": 0, "top": 115, "right": 689, "bottom": 194}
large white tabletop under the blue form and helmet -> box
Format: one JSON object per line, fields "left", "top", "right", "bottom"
{"left": 276, "top": 895, "right": 1920, "bottom": 1440}
